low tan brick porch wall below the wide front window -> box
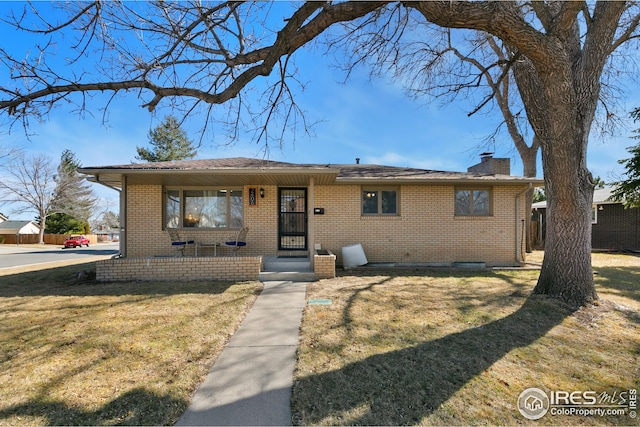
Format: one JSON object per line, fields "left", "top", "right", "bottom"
{"left": 96, "top": 256, "right": 262, "bottom": 282}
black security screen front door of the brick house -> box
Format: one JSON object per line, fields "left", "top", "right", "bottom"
{"left": 278, "top": 188, "right": 307, "bottom": 250}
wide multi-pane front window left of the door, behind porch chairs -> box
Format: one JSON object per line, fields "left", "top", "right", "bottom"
{"left": 164, "top": 189, "right": 243, "bottom": 228}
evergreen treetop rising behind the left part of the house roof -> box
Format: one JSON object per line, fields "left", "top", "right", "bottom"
{"left": 136, "top": 116, "right": 197, "bottom": 162}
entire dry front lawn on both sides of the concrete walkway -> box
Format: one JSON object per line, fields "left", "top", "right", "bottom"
{"left": 0, "top": 253, "right": 640, "bottom": 426}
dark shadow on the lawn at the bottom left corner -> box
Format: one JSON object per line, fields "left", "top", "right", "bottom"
{"left": 0, "top": 389, "right": 188, "bottom": 425}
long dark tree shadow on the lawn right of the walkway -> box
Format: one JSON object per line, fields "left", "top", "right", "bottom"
{"left": 293, "top": 296, "right": 572, "bottom": 425}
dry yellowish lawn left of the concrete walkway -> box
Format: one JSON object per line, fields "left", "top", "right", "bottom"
{"left": 0, "top": 264, "right": 260, "bottom": 426}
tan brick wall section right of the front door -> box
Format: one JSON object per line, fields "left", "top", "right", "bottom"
{"left": 315, "top": 185, "right": 526, "bottom": 265}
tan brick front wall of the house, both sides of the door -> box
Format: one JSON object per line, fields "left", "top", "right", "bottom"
{"left": 126, "top": 185, "right": 527, "bottom": 265}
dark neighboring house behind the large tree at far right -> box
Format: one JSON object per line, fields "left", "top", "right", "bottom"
{"left": 532, "top": 188, "right": 640, "bottom": 250}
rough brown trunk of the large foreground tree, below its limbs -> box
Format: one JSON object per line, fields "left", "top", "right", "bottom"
{"left": 512, "top": 36, "right": 599, "bottom": 306}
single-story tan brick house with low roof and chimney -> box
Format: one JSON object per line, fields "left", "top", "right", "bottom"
{"left": 80, "top": 156, "right": 542, "bottom": 280}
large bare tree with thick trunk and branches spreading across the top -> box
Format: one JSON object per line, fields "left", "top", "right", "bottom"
{"left": 0, "top": 1, "right": 640, "bottom": 305}
